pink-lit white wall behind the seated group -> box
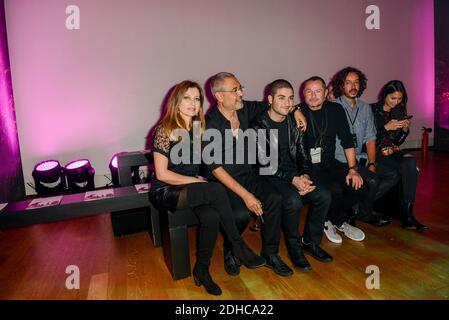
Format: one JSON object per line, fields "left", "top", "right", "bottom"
{"left": 5, "top": 0, "right": 434, "bottom": 193}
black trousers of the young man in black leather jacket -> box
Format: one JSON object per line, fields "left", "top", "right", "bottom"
{"left": 268, "top": 177, "right": 331, "bottom": 248}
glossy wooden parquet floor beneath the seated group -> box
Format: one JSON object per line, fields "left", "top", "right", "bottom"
{"left": 0, "top": 152, "right": 449, "bottom": 300}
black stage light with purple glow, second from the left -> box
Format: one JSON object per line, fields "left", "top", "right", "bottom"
{"left": 64, "top": 159, "right": 95, "bottom": 193}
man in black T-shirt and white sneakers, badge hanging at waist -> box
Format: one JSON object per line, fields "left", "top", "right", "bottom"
{"left": 300, "top": 76, "right": 367, "bottom": 243}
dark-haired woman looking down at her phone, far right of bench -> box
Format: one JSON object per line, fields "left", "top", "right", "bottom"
{"left": 371, "top": 80, "right": 428, "bottom": 231}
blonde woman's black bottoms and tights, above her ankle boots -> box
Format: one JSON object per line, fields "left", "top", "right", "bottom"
{"left": 150, "top": 182, "right": 241, "bottom": 266}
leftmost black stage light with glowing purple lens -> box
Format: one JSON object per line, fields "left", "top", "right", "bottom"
{"left": 31, "top": 160, "right": 64, "bottom": 196}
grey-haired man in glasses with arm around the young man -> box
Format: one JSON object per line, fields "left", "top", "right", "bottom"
{"left": 206, "top": 72, "right": 305, "bottom": 276}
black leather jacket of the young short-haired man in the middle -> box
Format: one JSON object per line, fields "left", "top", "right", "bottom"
{"left": 252, "top": 112, "right": 312, "bottom": 182}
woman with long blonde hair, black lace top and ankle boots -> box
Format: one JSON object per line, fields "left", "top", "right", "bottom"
{"left": 150, "top": 80, "right": 265, "bottom": 295}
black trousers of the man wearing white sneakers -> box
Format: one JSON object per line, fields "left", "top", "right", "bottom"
{"left": 311, "top": 160, "right": 369, "bottom": 227}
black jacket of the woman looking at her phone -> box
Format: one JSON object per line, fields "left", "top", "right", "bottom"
{"left": 371, "top": 102, "right": 410, "bottom": 150}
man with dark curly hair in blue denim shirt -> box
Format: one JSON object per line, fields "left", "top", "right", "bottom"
{"left": 332, "top": 67, "right": 399, "bottom": 226}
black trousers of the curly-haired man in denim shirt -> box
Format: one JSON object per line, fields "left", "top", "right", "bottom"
{"left": 359, "top": 163, "right": 399, "bottom": 220}
